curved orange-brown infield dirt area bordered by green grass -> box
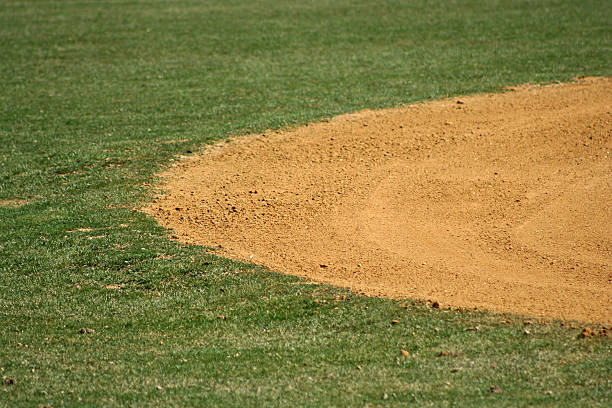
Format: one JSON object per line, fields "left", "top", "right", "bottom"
{"left": 146, "top": 78, "right": 612, "bottom": 324}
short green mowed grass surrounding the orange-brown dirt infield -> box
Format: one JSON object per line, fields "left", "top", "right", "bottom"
{"left": 0, "top": 0, "right": 612, "bottom": 407}
